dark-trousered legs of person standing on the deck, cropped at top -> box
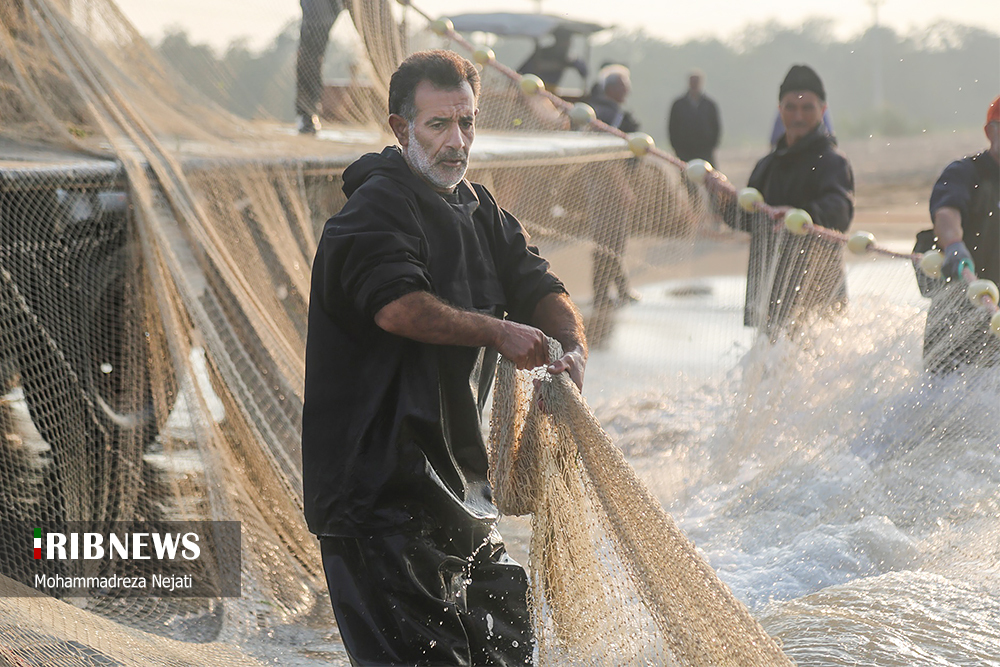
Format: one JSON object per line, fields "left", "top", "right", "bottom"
{"left": 295, "top": 0, "right": 344, "bottom": 134}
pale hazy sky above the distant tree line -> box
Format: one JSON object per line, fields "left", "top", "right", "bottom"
{"left": 115, "top": 0, "right": 1000, "bottom": 51}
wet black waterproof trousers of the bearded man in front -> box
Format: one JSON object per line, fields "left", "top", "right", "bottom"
{"left": 320, "top": 531, "right": 534, "bottom": 667}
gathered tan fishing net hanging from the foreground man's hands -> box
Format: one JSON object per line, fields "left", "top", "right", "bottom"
{"left": 490, "top": 342, "right": 792, "bottom": 667}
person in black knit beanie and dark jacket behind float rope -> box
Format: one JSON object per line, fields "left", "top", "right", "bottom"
{"left": 726, "top": 65, "right": 854, "bottom": 338}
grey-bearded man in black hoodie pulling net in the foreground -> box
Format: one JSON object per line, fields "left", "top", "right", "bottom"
{"left": 302, "top": 51, "right": 587, "bottom": 665}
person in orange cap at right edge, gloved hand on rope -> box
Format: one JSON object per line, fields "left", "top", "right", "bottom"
{"left": 924, "top": 96, "right": 1000, "bottom": 373}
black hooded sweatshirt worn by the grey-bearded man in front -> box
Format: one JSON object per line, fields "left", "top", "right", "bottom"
{"left": 302, "top": 147, "right": 565, "bottom": 537}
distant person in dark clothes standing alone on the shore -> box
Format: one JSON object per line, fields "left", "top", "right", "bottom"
{"left": 667, "top": 70, "right": 722, "bottom": 166}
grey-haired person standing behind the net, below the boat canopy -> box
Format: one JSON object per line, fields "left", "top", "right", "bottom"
{"left": 588, "top": 65, "right": 639, "bottom": 308}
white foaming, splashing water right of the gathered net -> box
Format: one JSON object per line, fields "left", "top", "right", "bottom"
{"left": 590, "top": 266, "right": 1000, "bottom": 666}
